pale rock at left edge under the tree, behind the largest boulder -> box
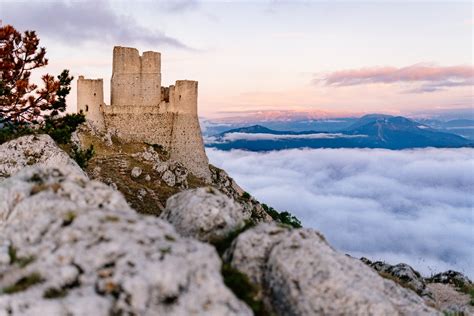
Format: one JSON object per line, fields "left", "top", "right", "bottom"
{"left": 0, "top": 134, "right": 85, "bottom": 180}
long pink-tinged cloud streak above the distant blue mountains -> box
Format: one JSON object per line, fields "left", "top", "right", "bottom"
{"left": 314, "top": 64, "right": 474, "bottom": 92}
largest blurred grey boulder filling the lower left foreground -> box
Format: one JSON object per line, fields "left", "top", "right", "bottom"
{"left": 0, "top": 166, "right": 251, "bottom": 315}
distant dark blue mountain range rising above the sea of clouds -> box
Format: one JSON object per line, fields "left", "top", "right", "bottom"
{"left": 205, "top": 114, "right": 474, "bottom": 151}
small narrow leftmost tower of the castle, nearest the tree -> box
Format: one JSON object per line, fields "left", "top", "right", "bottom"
{"left": 77, "top": 76, "right": 104, "bottom": 129}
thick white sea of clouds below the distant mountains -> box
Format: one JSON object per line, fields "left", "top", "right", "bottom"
{"left": 207, "top": 148, "right": 474, "bottom": 278}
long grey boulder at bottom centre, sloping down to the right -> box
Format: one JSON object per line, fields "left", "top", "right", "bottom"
{"left": 227, "top": 224, "right": 439, "bottom": 315}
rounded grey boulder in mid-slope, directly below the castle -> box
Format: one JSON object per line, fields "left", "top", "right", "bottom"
{"left": 160, "top": 187, "right": 250, "bottom": 242}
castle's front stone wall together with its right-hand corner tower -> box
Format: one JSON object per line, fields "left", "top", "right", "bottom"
{"left": 104, "top": 80, "right": 210, "bottom": 179}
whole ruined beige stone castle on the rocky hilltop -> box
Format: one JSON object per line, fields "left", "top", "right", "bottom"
{"left": 77, "top": 46, "right": 210, "bottom": 179}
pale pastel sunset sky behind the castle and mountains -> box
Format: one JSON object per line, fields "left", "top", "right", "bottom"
{"left": 0, "top": 0, "right": 474, "bottom": 118}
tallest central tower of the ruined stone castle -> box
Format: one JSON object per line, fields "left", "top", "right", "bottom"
{"left": 110, "top": 46, "right": 161, "bottom": 106}
